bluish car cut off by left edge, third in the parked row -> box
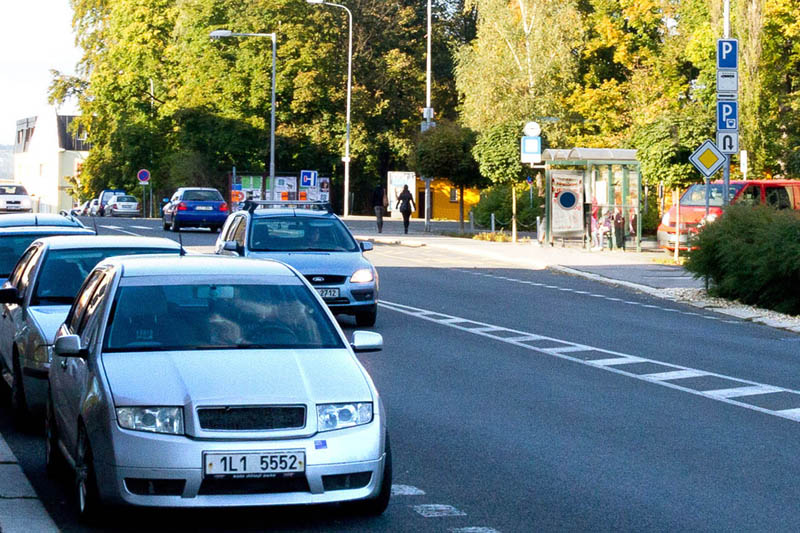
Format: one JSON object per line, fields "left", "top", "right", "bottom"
{"left": 0, "top": 213, "right": 94, "bottom": 283}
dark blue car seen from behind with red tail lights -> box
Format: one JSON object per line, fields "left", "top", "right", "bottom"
{"left": 161, "top": 187, "right": 228, "bottom": 231}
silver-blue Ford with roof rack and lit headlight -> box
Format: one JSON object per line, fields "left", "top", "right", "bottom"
{"left": 214, "top": 201, "right": 378, "bottom": 327}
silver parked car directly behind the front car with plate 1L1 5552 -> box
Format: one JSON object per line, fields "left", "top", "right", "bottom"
{"left": 0, "top": 235, "right": 180, "bottom": 420}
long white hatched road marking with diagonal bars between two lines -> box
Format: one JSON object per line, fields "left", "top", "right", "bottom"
{"left": 378, "top": 301, "right": 800, "bottom": 422}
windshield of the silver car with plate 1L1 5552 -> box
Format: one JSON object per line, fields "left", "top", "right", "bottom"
{"left": 103, "top": 283, "right": 343, "bottom": 353}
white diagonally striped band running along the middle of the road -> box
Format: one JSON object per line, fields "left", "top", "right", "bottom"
{"left": 378, "top": 301, "right": 800, "bottom": 421}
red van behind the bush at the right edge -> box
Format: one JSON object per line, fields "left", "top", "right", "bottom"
{"left": 658, "top": 180, "right": 800, "bottom": 250}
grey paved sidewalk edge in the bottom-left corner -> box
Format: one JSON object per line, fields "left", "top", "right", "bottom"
{"left": 0, "top": 434, "right": 59, "bottom": 533}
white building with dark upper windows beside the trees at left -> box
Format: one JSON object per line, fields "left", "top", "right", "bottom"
{"left": 14, "top": 108, "right": 90, "bottom": 213}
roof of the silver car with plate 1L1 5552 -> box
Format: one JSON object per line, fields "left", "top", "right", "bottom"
{"left": 98, "top": 254, "right": 297, "bottom": 279}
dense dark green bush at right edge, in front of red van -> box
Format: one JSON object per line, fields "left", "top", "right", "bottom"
{"left": 686, "top": 205, "right": 800, "bottom": 314}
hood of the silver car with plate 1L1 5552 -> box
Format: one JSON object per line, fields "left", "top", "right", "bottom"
{"left": 103, "top": 348, "right": 373, "bottom": 406}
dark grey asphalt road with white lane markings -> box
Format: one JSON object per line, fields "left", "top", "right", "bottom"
{"left": 0, "top": 215, "right": 800, "bottom": 533}
